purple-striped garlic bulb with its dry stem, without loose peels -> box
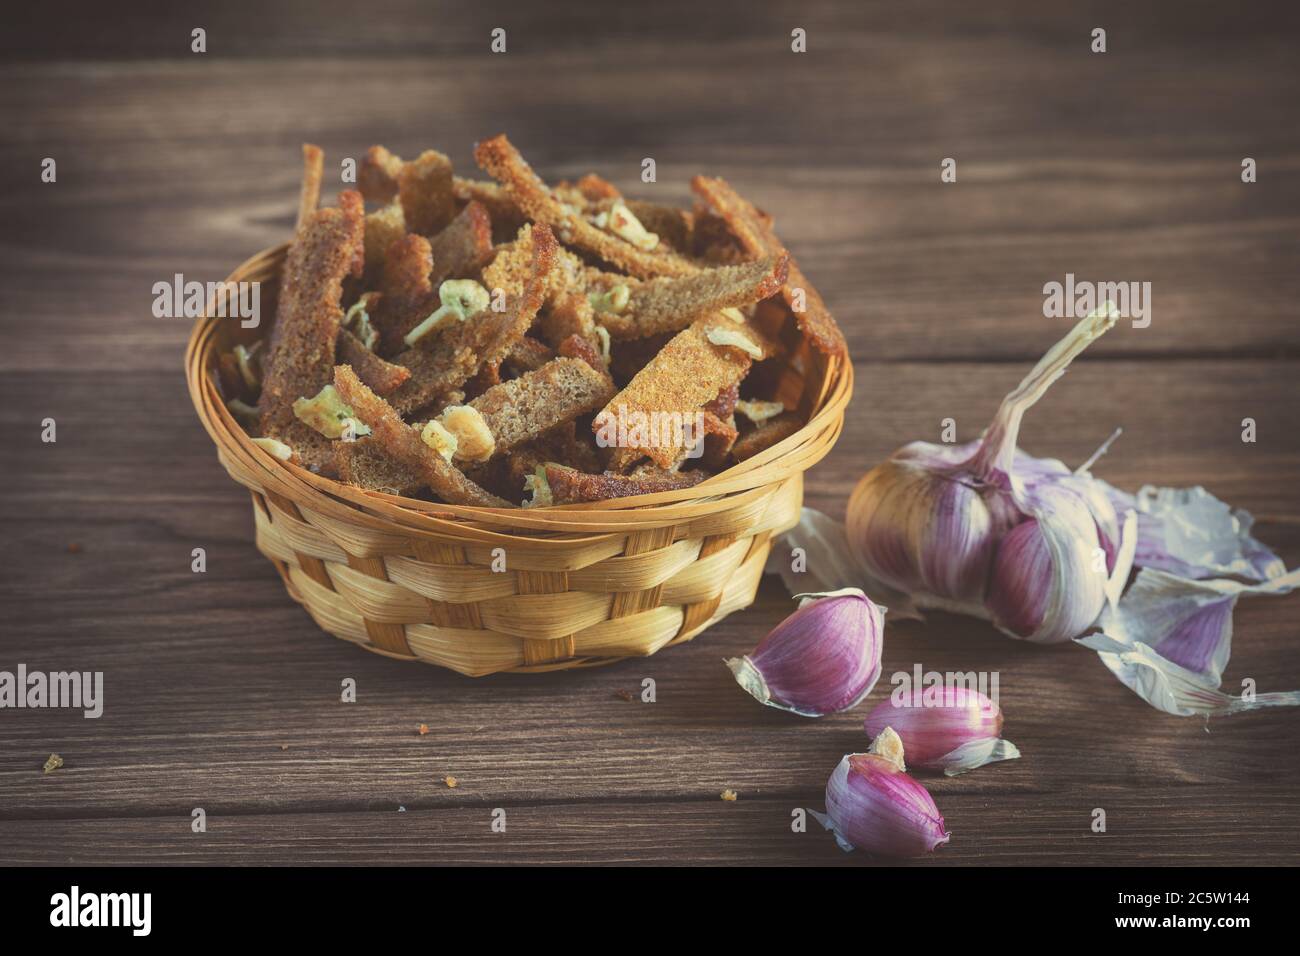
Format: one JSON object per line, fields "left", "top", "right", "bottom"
{"left": 848, "top": 303, "right": 1132, "bottom": 643}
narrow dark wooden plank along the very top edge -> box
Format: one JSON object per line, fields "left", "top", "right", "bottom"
{"left": 10, "top": 0, "right": 1297, "bottom": 61}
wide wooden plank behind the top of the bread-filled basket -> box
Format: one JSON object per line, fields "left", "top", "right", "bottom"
{"left": 0, "top": 23, "right": 1300, "bottom": 371}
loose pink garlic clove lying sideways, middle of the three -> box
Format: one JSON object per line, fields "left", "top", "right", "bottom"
{"left": 863, "top": 687, "right": 1021, "bottom": 777}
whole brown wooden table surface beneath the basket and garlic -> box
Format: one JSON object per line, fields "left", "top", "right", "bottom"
{"left": 0, "top": 0, "right": 1300, "bottom": 865}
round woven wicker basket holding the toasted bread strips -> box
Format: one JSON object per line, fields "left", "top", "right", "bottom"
{"left": 185, "top": 245, "right": 853, "bottom": 676}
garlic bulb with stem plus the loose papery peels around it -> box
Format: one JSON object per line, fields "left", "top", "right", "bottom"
{"left": 775, "top": 302, "right": 1300, "bottom": 717}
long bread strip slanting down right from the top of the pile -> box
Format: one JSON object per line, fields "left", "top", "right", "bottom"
{"left": 475, "top": 134, "right": 698, "bottom": 277}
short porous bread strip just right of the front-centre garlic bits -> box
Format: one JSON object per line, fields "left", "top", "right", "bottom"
{"left": 469, "top": 359, "right": 614, "bottom": 463}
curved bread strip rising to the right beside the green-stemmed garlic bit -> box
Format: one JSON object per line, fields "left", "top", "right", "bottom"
{"left": 391, "top": 224, "right": 556, "bottom": 414}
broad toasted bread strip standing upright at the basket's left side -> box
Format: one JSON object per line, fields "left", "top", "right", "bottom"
{"left": 257, "top": 190, "right": 365, "bottom": 470}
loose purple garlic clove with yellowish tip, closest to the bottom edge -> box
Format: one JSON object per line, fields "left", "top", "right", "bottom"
{"left": 811, "top": 728, "right": 949, "bottom": 857}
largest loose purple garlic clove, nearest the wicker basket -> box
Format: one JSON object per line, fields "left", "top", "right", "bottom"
{"left": 727, "top": 588, "right": 885, "bottom": 717}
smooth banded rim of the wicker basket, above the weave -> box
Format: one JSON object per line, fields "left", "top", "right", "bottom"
{"left": 185, "top": 242, "right": 853, "bottom": 545}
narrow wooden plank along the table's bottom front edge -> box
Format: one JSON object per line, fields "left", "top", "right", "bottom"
{"left": 0, "top": 787, "right": 1300, "bottom": 866}
